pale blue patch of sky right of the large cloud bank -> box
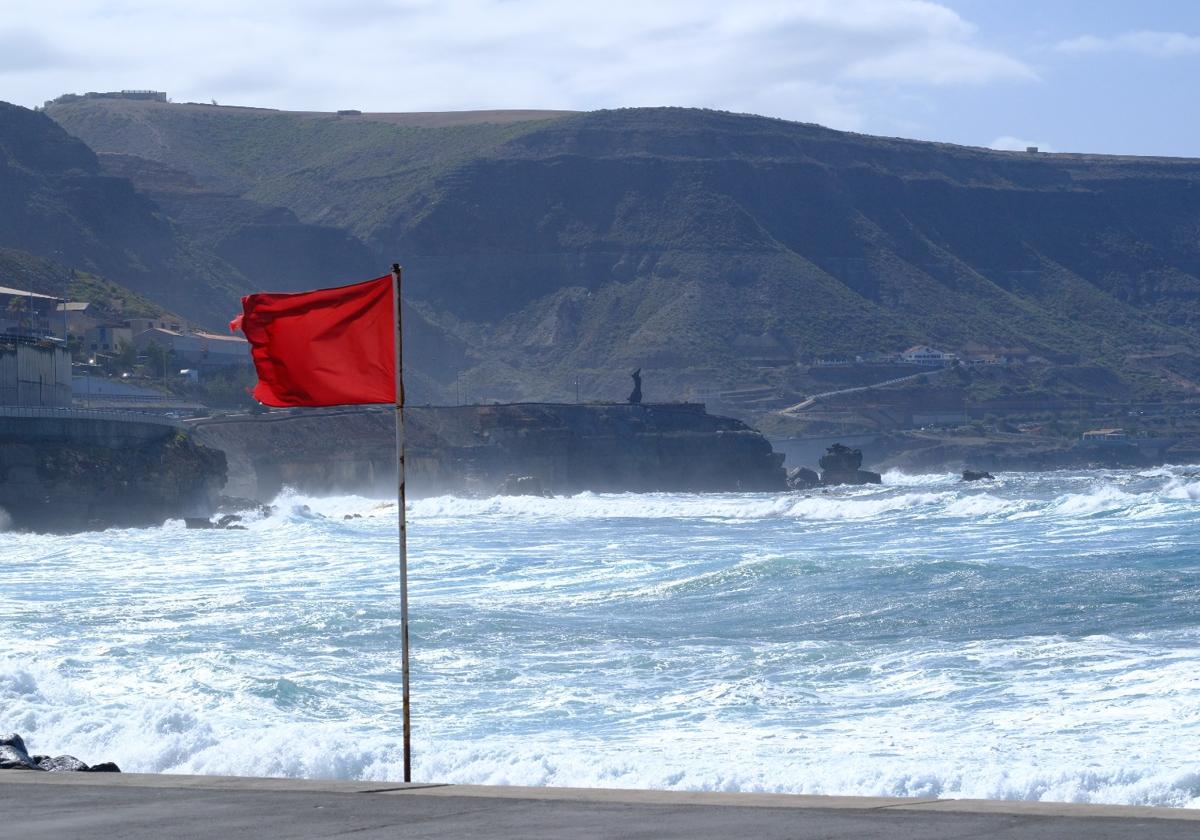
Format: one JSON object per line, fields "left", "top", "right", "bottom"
{"left": 907, "top": 0, "right": 1200, "bottom": 157}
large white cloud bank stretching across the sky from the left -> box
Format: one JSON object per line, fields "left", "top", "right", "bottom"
{"left": 0, "top": 0, "right": 1036, "bottom": 128}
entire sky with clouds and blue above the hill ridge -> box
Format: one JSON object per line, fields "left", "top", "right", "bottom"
{"left": 0, "top": 0, "right": 1200, "bottom": 157}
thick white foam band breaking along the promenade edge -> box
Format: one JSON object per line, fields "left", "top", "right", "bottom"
{"left": 0, "top": 662, "right": 1200, "bottom": 808}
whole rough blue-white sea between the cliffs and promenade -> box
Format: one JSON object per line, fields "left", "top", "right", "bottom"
{"left": 0, "top": 467, "right": 1200, "bottom": 806}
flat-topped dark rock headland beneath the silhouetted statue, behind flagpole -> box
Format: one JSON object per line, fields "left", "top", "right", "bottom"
{"left": 196, "top": 403, "right": 785, "bottom": 500}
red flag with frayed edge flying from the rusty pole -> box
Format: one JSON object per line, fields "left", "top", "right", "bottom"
{"left": 229, "top": 275, "right": 396, "bottom": 407}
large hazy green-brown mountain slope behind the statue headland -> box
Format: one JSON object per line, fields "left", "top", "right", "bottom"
{"left": 49, "top": 100, "right": 1200, "bottom": 398}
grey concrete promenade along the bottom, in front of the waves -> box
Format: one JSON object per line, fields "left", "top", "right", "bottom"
{"left": 0, "top": 770, "right": 1200, "bottom": 840}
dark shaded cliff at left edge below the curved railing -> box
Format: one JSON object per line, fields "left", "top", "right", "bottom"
{"left": 0, "top": 418, "right": 226, "bottom": 533}
